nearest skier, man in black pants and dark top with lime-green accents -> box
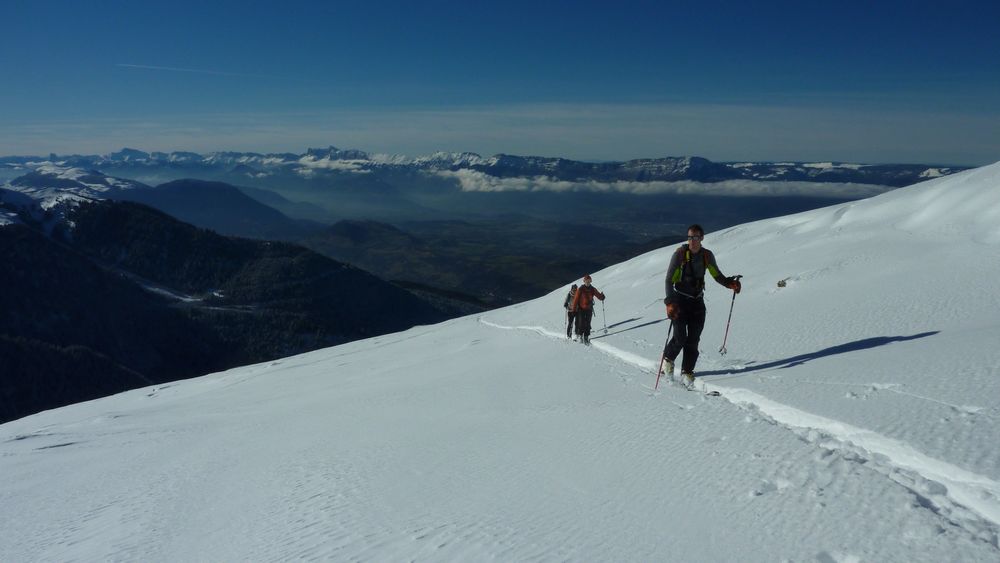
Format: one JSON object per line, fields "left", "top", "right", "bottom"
{"left": 661, "top": 224, "right": 742, "bottom": 388}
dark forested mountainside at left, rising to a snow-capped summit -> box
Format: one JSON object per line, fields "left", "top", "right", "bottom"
{"left": 0, "top": 169, "right": 457, "bottom": 420}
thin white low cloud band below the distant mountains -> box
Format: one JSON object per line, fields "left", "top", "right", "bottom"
{"left": 434, "top": 170, "right": 893, "bottom": 199}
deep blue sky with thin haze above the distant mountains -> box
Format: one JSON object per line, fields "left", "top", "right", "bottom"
{"left": 0, "top": 0, "right": 1000, "bottom": 164}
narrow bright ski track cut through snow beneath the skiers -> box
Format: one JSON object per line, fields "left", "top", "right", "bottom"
{"left": 479, "top": 318, "right": 1000, "bottom": 547}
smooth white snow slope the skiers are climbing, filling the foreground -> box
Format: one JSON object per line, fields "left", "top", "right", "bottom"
{"left": 0, "top": 164, "right": 1000, "bottom": 562}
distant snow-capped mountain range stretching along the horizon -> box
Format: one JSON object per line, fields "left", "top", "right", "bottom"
{"left": 0, "top": 146, "right": 967, "bottom": 187}
